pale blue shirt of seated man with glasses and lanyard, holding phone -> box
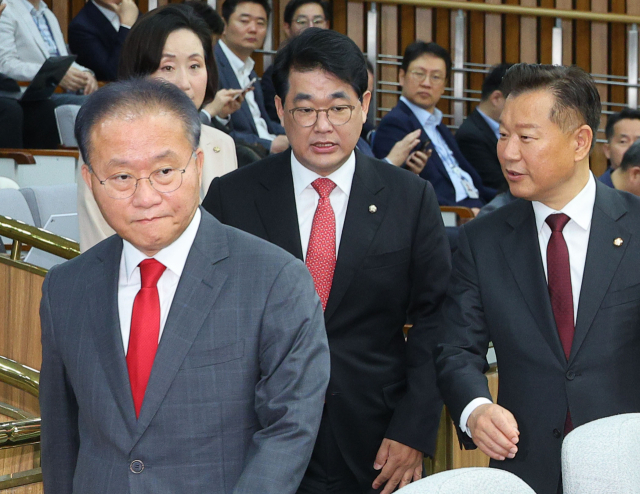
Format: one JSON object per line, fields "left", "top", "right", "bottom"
{"left": 400, "top": 96, "right": 480, "bottom": 202}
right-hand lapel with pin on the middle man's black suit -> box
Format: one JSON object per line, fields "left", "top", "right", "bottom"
{"left": 325, "top": 151, "right": 389, "bottom": 322}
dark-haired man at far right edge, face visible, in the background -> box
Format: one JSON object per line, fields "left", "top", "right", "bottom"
{"left": 598, "top": 108, "right": 640, "bottom": 187}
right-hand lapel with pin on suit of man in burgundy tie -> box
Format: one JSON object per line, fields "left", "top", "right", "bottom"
{"left": 569, "top": 181, "right": 631, "bottom": 362}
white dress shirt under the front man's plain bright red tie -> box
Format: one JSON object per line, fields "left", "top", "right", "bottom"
{"left": 118, "top": 209, "right": 202, "bottom": 355}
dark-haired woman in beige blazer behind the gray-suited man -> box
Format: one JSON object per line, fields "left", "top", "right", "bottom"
{"left": 78, "top": 4, "right": 238, "bottom": 252}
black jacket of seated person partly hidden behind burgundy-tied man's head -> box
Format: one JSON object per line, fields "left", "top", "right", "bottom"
{"left": 456, "top": 109, "right": 508, "bottom": 191}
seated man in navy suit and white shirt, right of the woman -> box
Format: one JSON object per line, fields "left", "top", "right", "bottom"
{"left": 215, "top": 0, "right": 289, "bottom": 153}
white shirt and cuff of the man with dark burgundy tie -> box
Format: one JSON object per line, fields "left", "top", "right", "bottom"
{"left": 460, "top": 172, "right": 596, "bottom": 437}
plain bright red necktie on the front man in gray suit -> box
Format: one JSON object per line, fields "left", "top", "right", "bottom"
{"left": 127, "top": 259, "right": 166, "bottom": 417}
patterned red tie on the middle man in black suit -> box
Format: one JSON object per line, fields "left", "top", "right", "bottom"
{"left": 306, "top": 178, "right": 336, "bottom": 310}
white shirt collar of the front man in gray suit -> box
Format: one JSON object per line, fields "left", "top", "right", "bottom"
{"left": 122, "top": 208, "right": 202, "bottom": 281}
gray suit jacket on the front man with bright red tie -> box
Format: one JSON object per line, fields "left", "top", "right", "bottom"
{"left": 40, "top": 211, "right": 329, "bottom": 494}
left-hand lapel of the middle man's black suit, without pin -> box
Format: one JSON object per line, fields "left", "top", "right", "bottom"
{"left": 255, "top": 150, "right": 304, "bottom": 260}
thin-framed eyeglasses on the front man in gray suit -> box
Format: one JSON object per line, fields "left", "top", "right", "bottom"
{"left": 89, "top": 153, "right": 196, "bottom": 199}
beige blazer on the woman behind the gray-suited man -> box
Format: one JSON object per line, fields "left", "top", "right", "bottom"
{"left": 77, "top": 125, "right": 238, "bottom": 252}
